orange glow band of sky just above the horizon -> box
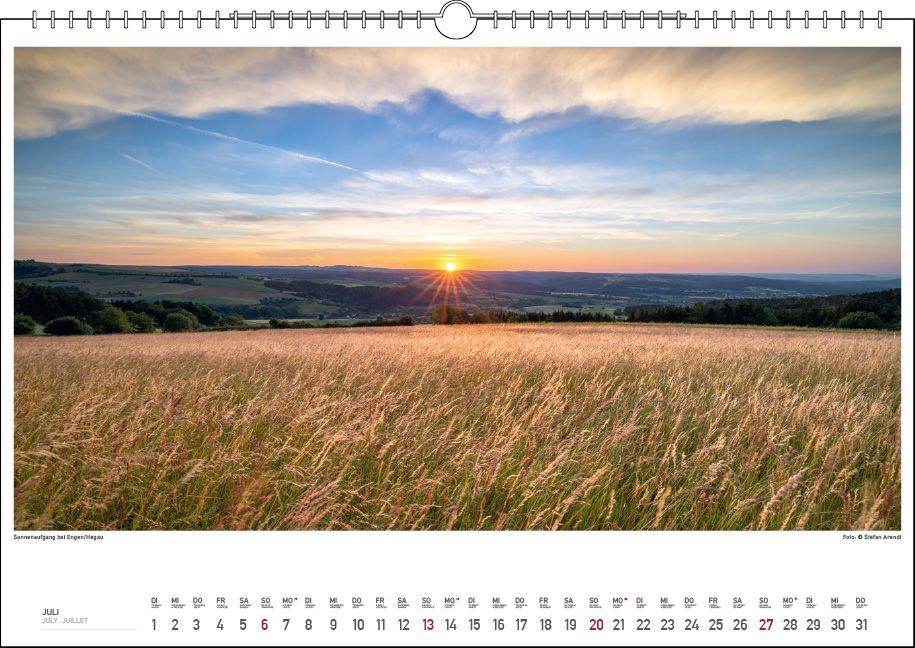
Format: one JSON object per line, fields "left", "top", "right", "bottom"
{"left": 15, "top": 238, "right": 900, "bottom": 278}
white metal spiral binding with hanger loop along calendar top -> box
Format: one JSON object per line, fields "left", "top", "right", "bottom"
{"left": 26, "top": 5, "right": 883, "bottom": 39}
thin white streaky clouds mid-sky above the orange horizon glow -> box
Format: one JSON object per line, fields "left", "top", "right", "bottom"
{"left": 19, "top": 159, "right": 898, "bottom": 256}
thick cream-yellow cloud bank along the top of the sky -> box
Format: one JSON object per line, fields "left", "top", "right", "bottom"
{"left": 15, "top": 48, "right": 901, "bottom": 139}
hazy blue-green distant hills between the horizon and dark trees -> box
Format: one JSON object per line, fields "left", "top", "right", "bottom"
{"left": 14, "top": 260, "right": 900, "bottom": 319}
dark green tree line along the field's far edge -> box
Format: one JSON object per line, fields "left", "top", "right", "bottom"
{"left": 14, "top": 282, "right": 902, "bottom": 335}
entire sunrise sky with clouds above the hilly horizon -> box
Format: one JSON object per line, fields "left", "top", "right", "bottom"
{"left": 15, "top": 48, "right": 901, "bottom": 273}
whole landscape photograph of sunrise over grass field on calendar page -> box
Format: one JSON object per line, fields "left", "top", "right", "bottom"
{"left": 12, "top": 47, "right": 910, "bottom": 532}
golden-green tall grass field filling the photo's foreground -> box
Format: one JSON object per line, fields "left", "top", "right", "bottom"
{"left": 15, "top": 324, "right": 901, "bottom": 529}
